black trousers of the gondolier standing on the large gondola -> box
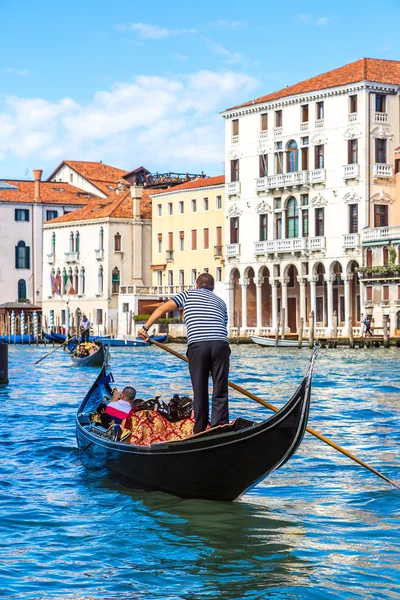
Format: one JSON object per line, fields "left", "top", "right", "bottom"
{"left": 187, "top": 340, "right": 231, "bottom": 433}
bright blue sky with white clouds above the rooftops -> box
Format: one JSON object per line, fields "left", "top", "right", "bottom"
{"left": 0, "top": 0, "right": 400, "bottom": 179}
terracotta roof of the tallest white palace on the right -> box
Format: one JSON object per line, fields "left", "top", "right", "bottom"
{"left": 227, "top": 58, "right": 400, "bottom": 110}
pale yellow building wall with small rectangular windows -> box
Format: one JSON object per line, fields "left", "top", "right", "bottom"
{"left": 152, "top": 185, "right": 225, "bottom": 292}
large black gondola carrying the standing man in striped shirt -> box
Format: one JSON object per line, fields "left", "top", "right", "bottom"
{"left": 76, "top": 352, "right": 316, "bottom": 501}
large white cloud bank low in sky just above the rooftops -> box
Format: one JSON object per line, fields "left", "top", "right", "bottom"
{"left": 0, "top": 71, "right": 257, "bottom": 172}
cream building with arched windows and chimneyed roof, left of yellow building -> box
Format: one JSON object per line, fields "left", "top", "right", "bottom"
{"left": 43, "top": 185, "right": 151, "bottom": 334}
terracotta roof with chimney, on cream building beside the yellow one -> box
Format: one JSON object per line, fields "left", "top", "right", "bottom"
{"left": 46, "top": 189, "right": 151, "bottom": 225}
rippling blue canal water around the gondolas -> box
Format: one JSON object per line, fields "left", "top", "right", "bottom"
{"left": 0, "top": 346, "right": 400, "bottom": 600}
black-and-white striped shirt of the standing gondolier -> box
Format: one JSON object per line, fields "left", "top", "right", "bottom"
{"left": 173, "top": 287, "right": 228, "bottom": 345}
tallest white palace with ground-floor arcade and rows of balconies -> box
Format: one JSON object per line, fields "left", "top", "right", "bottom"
{"left": 223, "top": 59, "right": 400, "bottom": 335}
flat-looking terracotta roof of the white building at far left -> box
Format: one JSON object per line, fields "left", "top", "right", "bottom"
{"left": 0, "top": 179, "right": 99, "bottom": 205}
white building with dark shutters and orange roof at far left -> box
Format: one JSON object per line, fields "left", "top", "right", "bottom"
{"left": 0, "top": 169, "right": 96, "bottom": 306}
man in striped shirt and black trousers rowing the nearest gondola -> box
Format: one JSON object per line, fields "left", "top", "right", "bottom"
{"left": 139, "top": 273, "right": 230, "bottom": 433}
